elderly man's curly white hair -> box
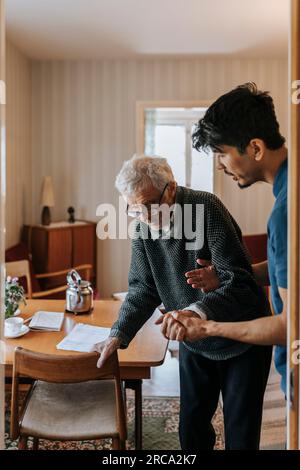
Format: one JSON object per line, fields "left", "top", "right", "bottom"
{"left": 115, "top": 155, "right": 174, "bottom": 195}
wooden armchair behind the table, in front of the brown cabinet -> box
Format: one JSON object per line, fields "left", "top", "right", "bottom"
{"left": 5, "top": 259, "right": 92, "bottom": 299}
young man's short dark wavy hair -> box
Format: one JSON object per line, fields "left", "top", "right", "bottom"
{"left": 192, "top": 82, "right": 285, "bottom": 154}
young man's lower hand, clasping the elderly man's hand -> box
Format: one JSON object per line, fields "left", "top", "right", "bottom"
{"left": 172, "top": 311, "right": 214, "bottom": 342}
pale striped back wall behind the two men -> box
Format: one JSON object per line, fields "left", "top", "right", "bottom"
{"left": 32, "top": 58, "right": 287, "bottom": 296}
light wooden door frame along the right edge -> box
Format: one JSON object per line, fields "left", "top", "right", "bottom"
{"left": 287, "top": 0, "right": 300, "bottom": 450}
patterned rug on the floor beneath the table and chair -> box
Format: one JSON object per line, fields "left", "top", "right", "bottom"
{"left": 5, "top": 393, "right": 224, "bottom": 450}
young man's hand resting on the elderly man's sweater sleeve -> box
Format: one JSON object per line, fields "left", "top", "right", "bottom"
{"left": 185, "top": 259, "right": 220, "bottom": 293}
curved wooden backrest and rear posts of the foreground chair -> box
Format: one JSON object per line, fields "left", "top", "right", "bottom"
{"left": 11, "top": 347, "right": 126, "bottom": 440}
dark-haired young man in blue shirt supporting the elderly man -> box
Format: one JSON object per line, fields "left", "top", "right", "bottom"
{"left": 163, "top": 83, "right": 287, "bottom": 393}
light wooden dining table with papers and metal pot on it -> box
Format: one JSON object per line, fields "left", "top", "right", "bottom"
{"left": 3, "top": 299, "right": 168, "bottom": 449}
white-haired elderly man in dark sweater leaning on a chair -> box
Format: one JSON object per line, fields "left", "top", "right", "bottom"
{"left": 96, "top": 156, "right": 271, "bottom": 450}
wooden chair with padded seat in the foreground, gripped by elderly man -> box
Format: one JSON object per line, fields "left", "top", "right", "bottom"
{"left": 10, "top": 347, "right": 126, "bottom": 450}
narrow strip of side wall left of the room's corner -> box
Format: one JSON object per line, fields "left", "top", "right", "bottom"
{"left": 6, "top": 40, "right": 34, "bottom": 247}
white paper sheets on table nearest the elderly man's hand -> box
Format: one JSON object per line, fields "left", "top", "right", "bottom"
{"left": 56, "top": 323, "right": 110, "bottom": 352}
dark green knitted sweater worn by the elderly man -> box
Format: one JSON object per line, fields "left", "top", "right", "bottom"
{"left": 110, "top": 187, "right": 270, "bottom": 360}
